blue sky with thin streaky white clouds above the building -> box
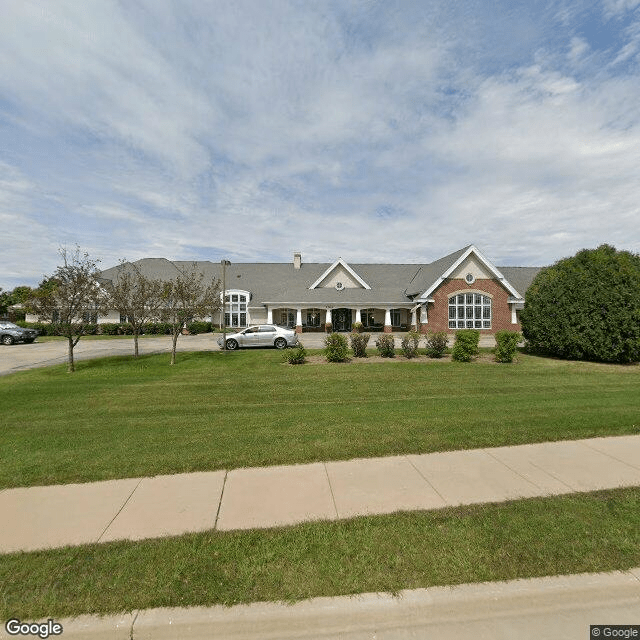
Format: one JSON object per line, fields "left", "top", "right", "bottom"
{"left": 0, "top": 0, "right": 640, "bottom": 290}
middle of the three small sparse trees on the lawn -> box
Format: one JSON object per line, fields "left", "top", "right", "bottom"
{"left": 104, "top": 260, "right": 163, "bottom": 358}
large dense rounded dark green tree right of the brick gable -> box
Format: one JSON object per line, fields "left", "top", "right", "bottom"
{"left": 520, "top": 244, "right": 640, "bottom": 362}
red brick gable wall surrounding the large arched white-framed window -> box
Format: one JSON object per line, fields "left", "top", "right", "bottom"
{"left": 422, "top": 278, "right": 520, "bottom": 333}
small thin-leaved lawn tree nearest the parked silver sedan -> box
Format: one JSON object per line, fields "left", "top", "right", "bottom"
{"left": 162, "top": 263, "right": 221, "bottom": 364}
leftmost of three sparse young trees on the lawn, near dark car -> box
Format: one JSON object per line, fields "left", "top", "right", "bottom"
{"left": 28, "top": 246, "right": 108, "bottom": 373}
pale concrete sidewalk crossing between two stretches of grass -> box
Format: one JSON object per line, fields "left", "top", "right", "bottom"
{"left": 0, "top": 435, "right": 640, "bottom": 553}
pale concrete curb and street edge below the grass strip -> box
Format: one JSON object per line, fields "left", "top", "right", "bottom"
{"left": 0, "top": 568, "right": 640, "bottom": 640}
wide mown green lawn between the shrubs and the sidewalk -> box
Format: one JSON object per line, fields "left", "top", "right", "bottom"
{"left": 0, "top": 350, "right": 640, "bottom": 488}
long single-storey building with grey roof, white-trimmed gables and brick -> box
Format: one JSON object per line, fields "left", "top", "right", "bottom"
{"left": 99, "top": 245, "right": 540, "bottom": 333}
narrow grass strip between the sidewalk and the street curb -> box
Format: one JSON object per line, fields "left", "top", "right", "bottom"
{"left": 0, "top": 488, "right": 640, "bottom": 620}
